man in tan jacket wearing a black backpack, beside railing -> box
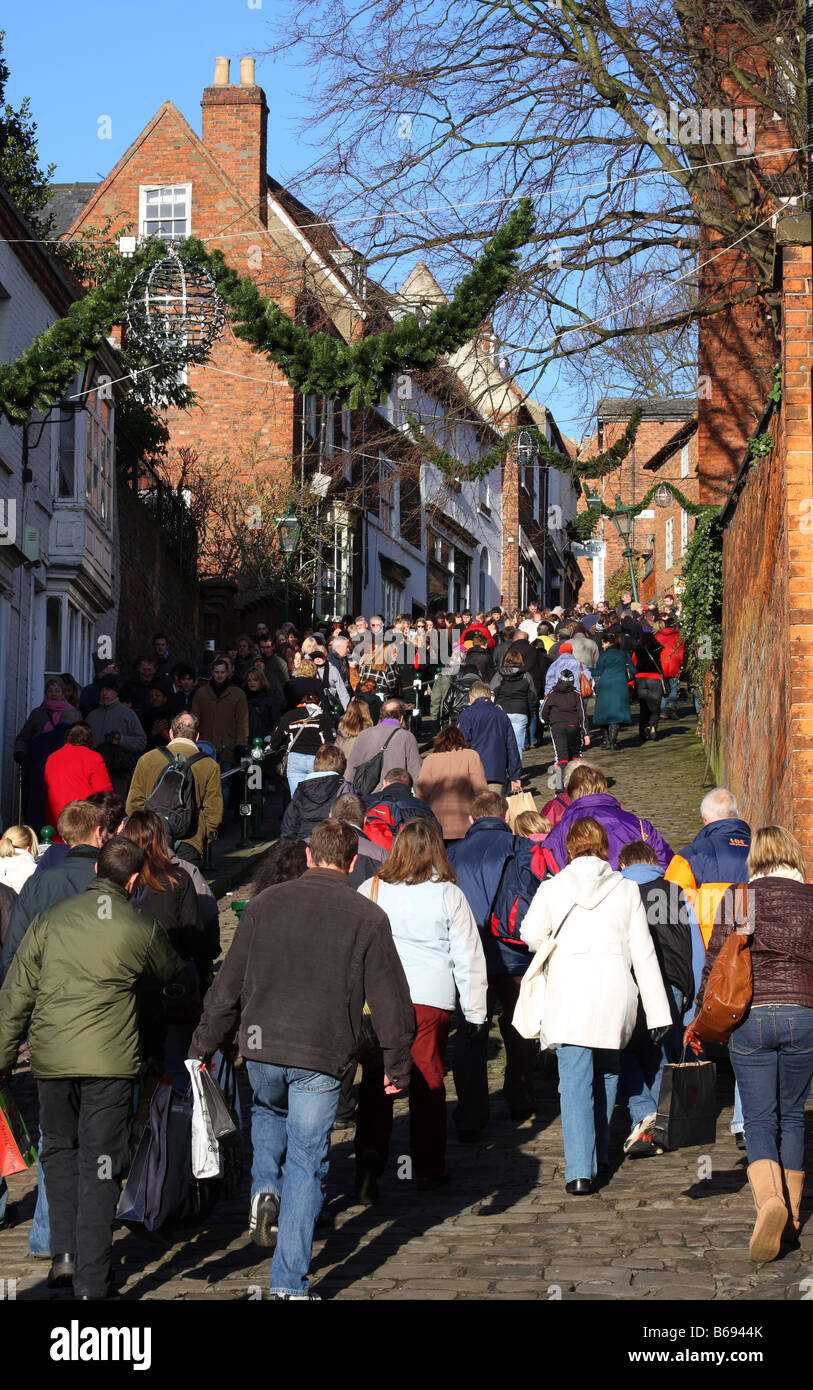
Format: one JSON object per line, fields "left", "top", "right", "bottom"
{"left": 126, "top": 712, "right": 222, "bottom": 865}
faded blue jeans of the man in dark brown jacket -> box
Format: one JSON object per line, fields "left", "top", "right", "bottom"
{"left": 247, "top": 1062, "right": 342, "bottom": 1294}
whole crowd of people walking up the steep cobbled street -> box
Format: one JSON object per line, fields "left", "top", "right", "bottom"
{"left": 0, "top": 594, "right": 813, "bottom": 1298}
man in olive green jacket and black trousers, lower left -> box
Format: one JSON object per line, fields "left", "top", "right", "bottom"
{"left": 0, "top": 835, "right": 183, "bottom": 1300}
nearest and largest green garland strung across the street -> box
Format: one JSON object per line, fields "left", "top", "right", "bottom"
{"left": 0, "top": 197, "right": 534, "bottom": 424}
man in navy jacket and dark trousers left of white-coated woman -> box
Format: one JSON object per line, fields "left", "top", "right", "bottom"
{"left": 447, "top": 791, "right": 536, "bottom": 1144}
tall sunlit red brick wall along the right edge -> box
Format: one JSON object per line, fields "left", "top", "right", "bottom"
{"left": 720, "top": 246, "right": 813, "bottom": 872}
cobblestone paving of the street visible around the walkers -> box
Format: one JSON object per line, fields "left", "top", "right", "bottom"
{"left": 0, "top": 706, "right": 813, "bottom": 1301}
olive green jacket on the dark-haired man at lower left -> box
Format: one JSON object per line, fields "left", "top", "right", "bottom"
{"left": 0, "top": 870, "right": 183, "bottom": 1080}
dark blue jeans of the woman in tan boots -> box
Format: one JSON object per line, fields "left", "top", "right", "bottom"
{"left": 728, "top": 1004, "right": 813, "bottom": 1172}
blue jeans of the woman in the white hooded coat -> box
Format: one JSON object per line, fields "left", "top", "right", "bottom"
{"left": 556, "top": 1043, "right": 620, "bottom": 1183}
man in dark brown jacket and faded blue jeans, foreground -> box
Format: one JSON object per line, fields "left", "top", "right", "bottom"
{"left": 189, "top": 820, "right": 414, "bottom": 1298}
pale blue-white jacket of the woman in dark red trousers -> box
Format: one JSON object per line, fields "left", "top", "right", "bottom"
{"left": 359, "top": 878, "right": 488, "bottom": 1023}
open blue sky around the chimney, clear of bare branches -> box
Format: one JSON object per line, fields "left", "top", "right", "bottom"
{"left": 0, "top": 0, "right": 588, "bottom": 436}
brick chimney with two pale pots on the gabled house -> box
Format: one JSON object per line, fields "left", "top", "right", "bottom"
{"left": 200, "top": 58, "right": 268, "bottom": 224}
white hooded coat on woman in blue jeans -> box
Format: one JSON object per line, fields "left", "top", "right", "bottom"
{"left": 520, "top": 838, "right": 671, "bottom": 1051}
